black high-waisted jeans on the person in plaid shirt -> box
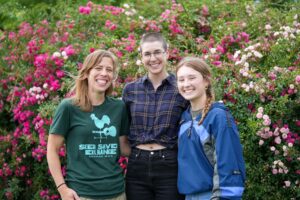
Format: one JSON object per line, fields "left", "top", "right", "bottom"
{"left": 126, "top": 148, "right": 184, "bottom": 200}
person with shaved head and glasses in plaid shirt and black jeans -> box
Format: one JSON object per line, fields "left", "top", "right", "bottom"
{"left": 123, "top": 33, "right": 188, "bottom": 200}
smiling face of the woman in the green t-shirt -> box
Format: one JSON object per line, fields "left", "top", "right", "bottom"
{"left": 87, "top": 57, "right": 115, "bottom": 94}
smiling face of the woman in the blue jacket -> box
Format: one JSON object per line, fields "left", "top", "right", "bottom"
{"left": 177, "top": 65, "right": 208, "bottom": 103}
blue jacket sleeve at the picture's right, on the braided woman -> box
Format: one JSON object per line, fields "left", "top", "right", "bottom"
{"left": 212, "top": 111, "right": 245, "bottom": 200}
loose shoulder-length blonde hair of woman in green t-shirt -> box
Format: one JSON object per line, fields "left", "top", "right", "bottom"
{"left": 71, "top": 50, "right": 118, "bottom": 111}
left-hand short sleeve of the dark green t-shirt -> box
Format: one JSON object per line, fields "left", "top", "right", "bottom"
{"left": 49, "top": 100, "right": 70, "bottom": 136}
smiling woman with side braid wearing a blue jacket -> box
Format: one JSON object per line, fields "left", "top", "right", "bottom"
{"left": 176, "top": 57, "right": 245, "bottom": 200}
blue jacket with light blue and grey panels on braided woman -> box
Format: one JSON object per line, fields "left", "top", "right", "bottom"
{"left": 178, "top": 102, "right": 245, "bottom": 199}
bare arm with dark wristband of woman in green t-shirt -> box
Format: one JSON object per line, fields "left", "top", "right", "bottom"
{"left": 47, "top": 134, "right": 80, "bottom": 200}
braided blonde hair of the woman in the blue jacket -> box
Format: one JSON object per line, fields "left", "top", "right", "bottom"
{"left": 176, "top": 57, "right": 215, "bottom": 125}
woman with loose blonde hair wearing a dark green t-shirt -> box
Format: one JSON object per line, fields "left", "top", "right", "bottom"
{"left": 47, "top": 50, "right": 130, "bottom": 200}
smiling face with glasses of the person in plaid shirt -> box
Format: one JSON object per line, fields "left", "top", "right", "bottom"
{"left": 141, "top": 41, "right": 169, "bottom": 76}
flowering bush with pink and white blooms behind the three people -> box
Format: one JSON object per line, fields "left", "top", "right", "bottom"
{"left": 0, "top": 0, "right": 300, "bottom": 200}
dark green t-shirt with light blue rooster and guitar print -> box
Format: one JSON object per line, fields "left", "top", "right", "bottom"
{"left": 50, "top": 97, "right": 129, "bottom": 198}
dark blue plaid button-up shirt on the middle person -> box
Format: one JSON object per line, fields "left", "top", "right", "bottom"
{"left": 123, "top": 74, "right": 188, "bottom": 148}
